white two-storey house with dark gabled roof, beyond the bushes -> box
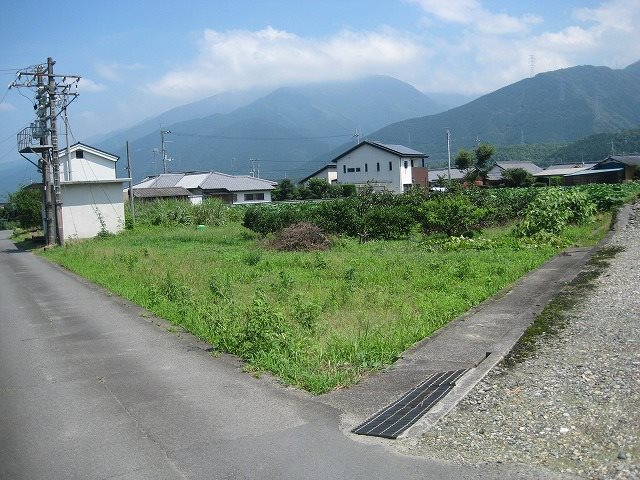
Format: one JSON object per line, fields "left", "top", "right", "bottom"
{"left": 333, "top": 141, "right": 427, "bottom": 193}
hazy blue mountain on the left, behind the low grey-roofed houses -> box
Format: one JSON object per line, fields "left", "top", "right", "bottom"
{"left": 96, "top": 76, "right": 442, "bottom": 182}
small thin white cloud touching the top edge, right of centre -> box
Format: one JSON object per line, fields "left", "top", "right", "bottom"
{"left": 407, "top": 0, "right": 542, "bottom": 35}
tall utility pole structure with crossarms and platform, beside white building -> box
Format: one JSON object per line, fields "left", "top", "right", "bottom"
{"left": 9, "top": 57, "right": 80, "bottom": 245}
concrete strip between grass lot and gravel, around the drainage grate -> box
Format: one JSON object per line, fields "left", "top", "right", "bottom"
{"left": 319, "top": 205, "right": 631, "bottom": 443}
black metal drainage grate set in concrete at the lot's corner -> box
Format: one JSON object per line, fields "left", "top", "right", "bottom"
{"left": 351, "top": 369, "right": 468, "bottom": 439}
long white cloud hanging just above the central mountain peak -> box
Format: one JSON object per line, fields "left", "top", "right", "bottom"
{"left": 148, "top": 27, "right": 428, "bottom": 98}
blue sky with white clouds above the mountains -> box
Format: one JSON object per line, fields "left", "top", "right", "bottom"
{"left": 0, "top": 0, "right": 640, "bottom": 172}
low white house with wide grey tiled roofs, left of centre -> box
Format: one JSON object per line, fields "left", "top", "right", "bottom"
{"left": 133, "top": 172, "right": 277, "bottom": 205}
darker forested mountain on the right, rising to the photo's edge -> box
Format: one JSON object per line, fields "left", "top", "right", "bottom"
{"left": 369, "top": 62, "right": 640, "bottom": 165}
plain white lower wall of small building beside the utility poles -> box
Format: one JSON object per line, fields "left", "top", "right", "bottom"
{"left": 61, "top": 182, "right": 124, "bottom": 239}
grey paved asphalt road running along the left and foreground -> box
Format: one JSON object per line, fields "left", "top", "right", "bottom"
{"left": 0, "top": 232, "right": 556, "bottom": 480}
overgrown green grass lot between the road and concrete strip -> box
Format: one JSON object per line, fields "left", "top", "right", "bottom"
{"left": 42, "top": 219, "right": 608, "bottom": 393}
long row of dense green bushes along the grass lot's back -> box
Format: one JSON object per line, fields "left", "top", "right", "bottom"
{"left": 244, "top": 182, "right": 640, "bottom": 241}
